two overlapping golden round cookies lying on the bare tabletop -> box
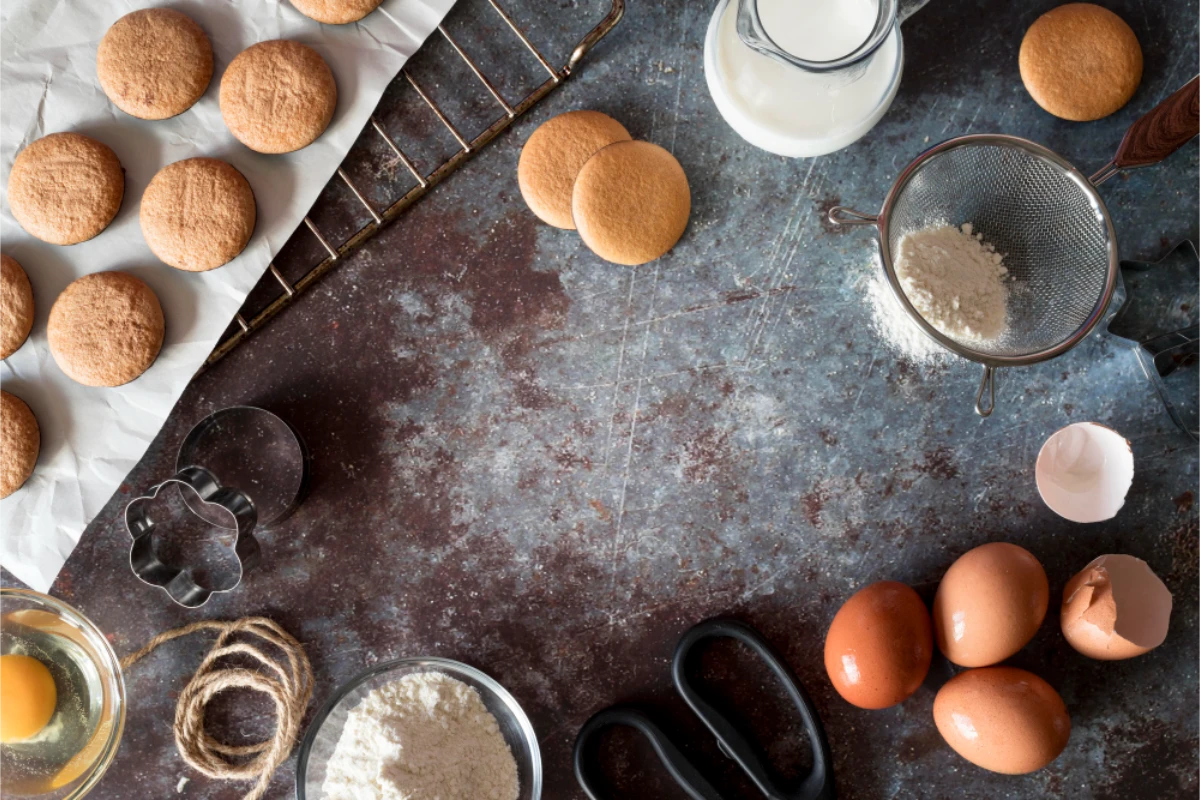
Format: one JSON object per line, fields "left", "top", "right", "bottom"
{"left": 517, "top": 112, "right": 691, "bottom": 266}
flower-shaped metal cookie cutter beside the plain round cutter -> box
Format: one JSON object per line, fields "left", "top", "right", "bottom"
{"left": 125, "top": 467, "right": 260, "bottom": 608}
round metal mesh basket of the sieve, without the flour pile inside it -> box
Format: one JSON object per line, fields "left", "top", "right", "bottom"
{"left": 882, "top": 138, "right": 1114, "bottom": 361}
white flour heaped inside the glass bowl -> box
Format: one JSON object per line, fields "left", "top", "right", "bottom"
{"left": 322, "top": 672, "right": 520, "bottom": 800}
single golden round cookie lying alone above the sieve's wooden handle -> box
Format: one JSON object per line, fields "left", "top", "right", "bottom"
{"left": 1019, "top": 2, "right": 1142, "bottom": 122}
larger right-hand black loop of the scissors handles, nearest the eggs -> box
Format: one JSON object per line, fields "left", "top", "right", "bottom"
{"left": 671, "top": 619, "right": 838, "bottom": 800}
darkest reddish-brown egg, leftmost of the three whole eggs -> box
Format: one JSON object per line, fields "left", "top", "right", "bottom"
{"left": 826, "top": 581, "right": 934, "bottom": 709}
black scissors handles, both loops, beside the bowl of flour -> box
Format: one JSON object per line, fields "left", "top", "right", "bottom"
{"left": 575, "top": 619, "right": 838, "bottom": 800}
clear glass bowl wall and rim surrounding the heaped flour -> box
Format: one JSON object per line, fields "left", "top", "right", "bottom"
{"left": 296, "top": 658, "right": 541, "bottom": 800}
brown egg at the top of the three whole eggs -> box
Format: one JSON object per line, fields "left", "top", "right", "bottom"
{"left": 934, "top": 542, "right": 1050, "bottom": 667}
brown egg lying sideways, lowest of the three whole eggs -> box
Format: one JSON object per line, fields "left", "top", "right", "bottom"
{"left": 934, "top": 667, "right": 1070, "bottom": 775}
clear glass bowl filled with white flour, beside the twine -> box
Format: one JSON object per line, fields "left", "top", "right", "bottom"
{"left": 296, "top": 658, "right": 541, "bottom": 800}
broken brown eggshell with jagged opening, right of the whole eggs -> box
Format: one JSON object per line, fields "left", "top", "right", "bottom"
{"left": 1060, "top": 555, "right": 1172, "bottom": 661}
